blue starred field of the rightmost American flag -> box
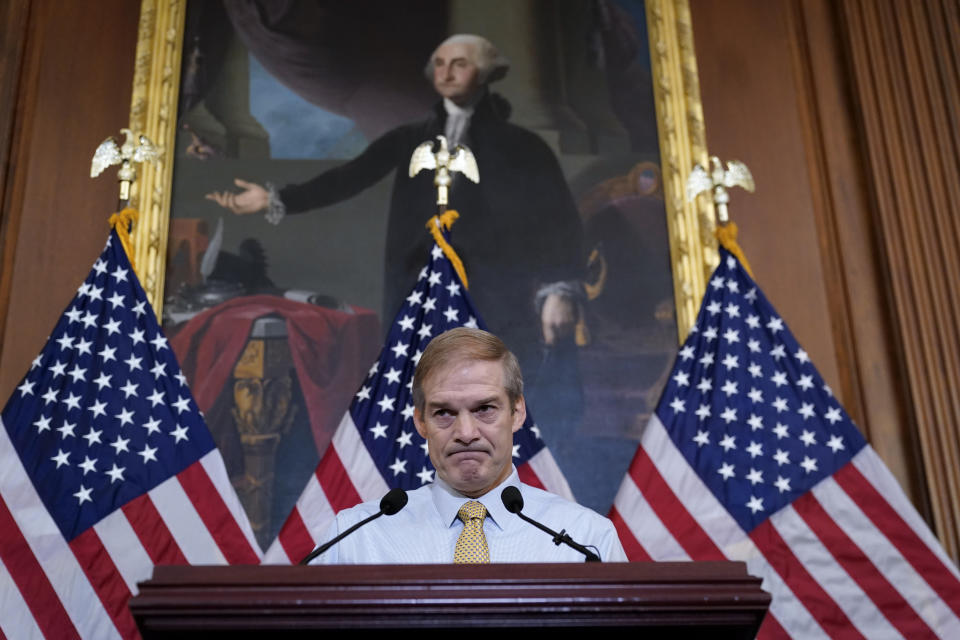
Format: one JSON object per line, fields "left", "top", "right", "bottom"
{"left": 657, "top": 249, "right": 866, "bottom": 532}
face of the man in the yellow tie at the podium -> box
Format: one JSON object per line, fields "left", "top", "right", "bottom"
{"left": 413, "top": 360, "right": 527, "bottom": 498}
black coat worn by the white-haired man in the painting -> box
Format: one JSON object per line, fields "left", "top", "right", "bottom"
{"left": 280, "top": 93, "right": 584, "bottom": 370}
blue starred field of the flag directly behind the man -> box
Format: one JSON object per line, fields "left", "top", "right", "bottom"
{"left": 350, "top": 230, "right": 544, "bottom": 489}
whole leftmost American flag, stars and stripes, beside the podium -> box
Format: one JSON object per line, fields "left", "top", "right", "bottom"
{"left": 0, "top": 231, "right": 261, "bottom": 638}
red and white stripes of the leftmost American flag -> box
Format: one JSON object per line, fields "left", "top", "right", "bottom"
{"left": 0, "top": 421, "right": 261, "bottom": 639}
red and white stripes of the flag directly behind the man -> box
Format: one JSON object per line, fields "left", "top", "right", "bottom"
{"left": 263, "top": 411, "right": 573, "bottom": 564}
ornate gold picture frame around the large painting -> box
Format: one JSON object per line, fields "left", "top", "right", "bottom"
{"left": 130, "top": 0, "right": 718, "bottom": 342}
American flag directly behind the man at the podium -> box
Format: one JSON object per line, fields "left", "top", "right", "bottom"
{"left": 264, "top": 222, "right": 572, "bottom": 564}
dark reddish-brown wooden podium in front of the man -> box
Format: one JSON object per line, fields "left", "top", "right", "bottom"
{"left": 130, "top": 562, "right": 770, "bottom": 639}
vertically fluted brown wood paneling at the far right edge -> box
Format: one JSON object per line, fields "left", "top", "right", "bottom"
{"left": 841, "top": 0, "right": 960, "bottom": 559}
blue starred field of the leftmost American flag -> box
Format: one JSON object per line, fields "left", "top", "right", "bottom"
{"left": 2, "top": 231, "right": 214, "bottom": 540}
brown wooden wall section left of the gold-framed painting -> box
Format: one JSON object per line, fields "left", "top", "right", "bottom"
{"left": 0, "top": 0, "right": 140, "bottom": 402}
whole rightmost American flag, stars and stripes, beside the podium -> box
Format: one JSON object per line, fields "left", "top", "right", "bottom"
{"left": 611, "top": 249, "right": 960, "bottom": 638}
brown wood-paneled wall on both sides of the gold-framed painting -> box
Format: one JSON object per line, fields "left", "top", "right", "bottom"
{"left": 0, "top": 0, "right": 960, "bottom": 558}
